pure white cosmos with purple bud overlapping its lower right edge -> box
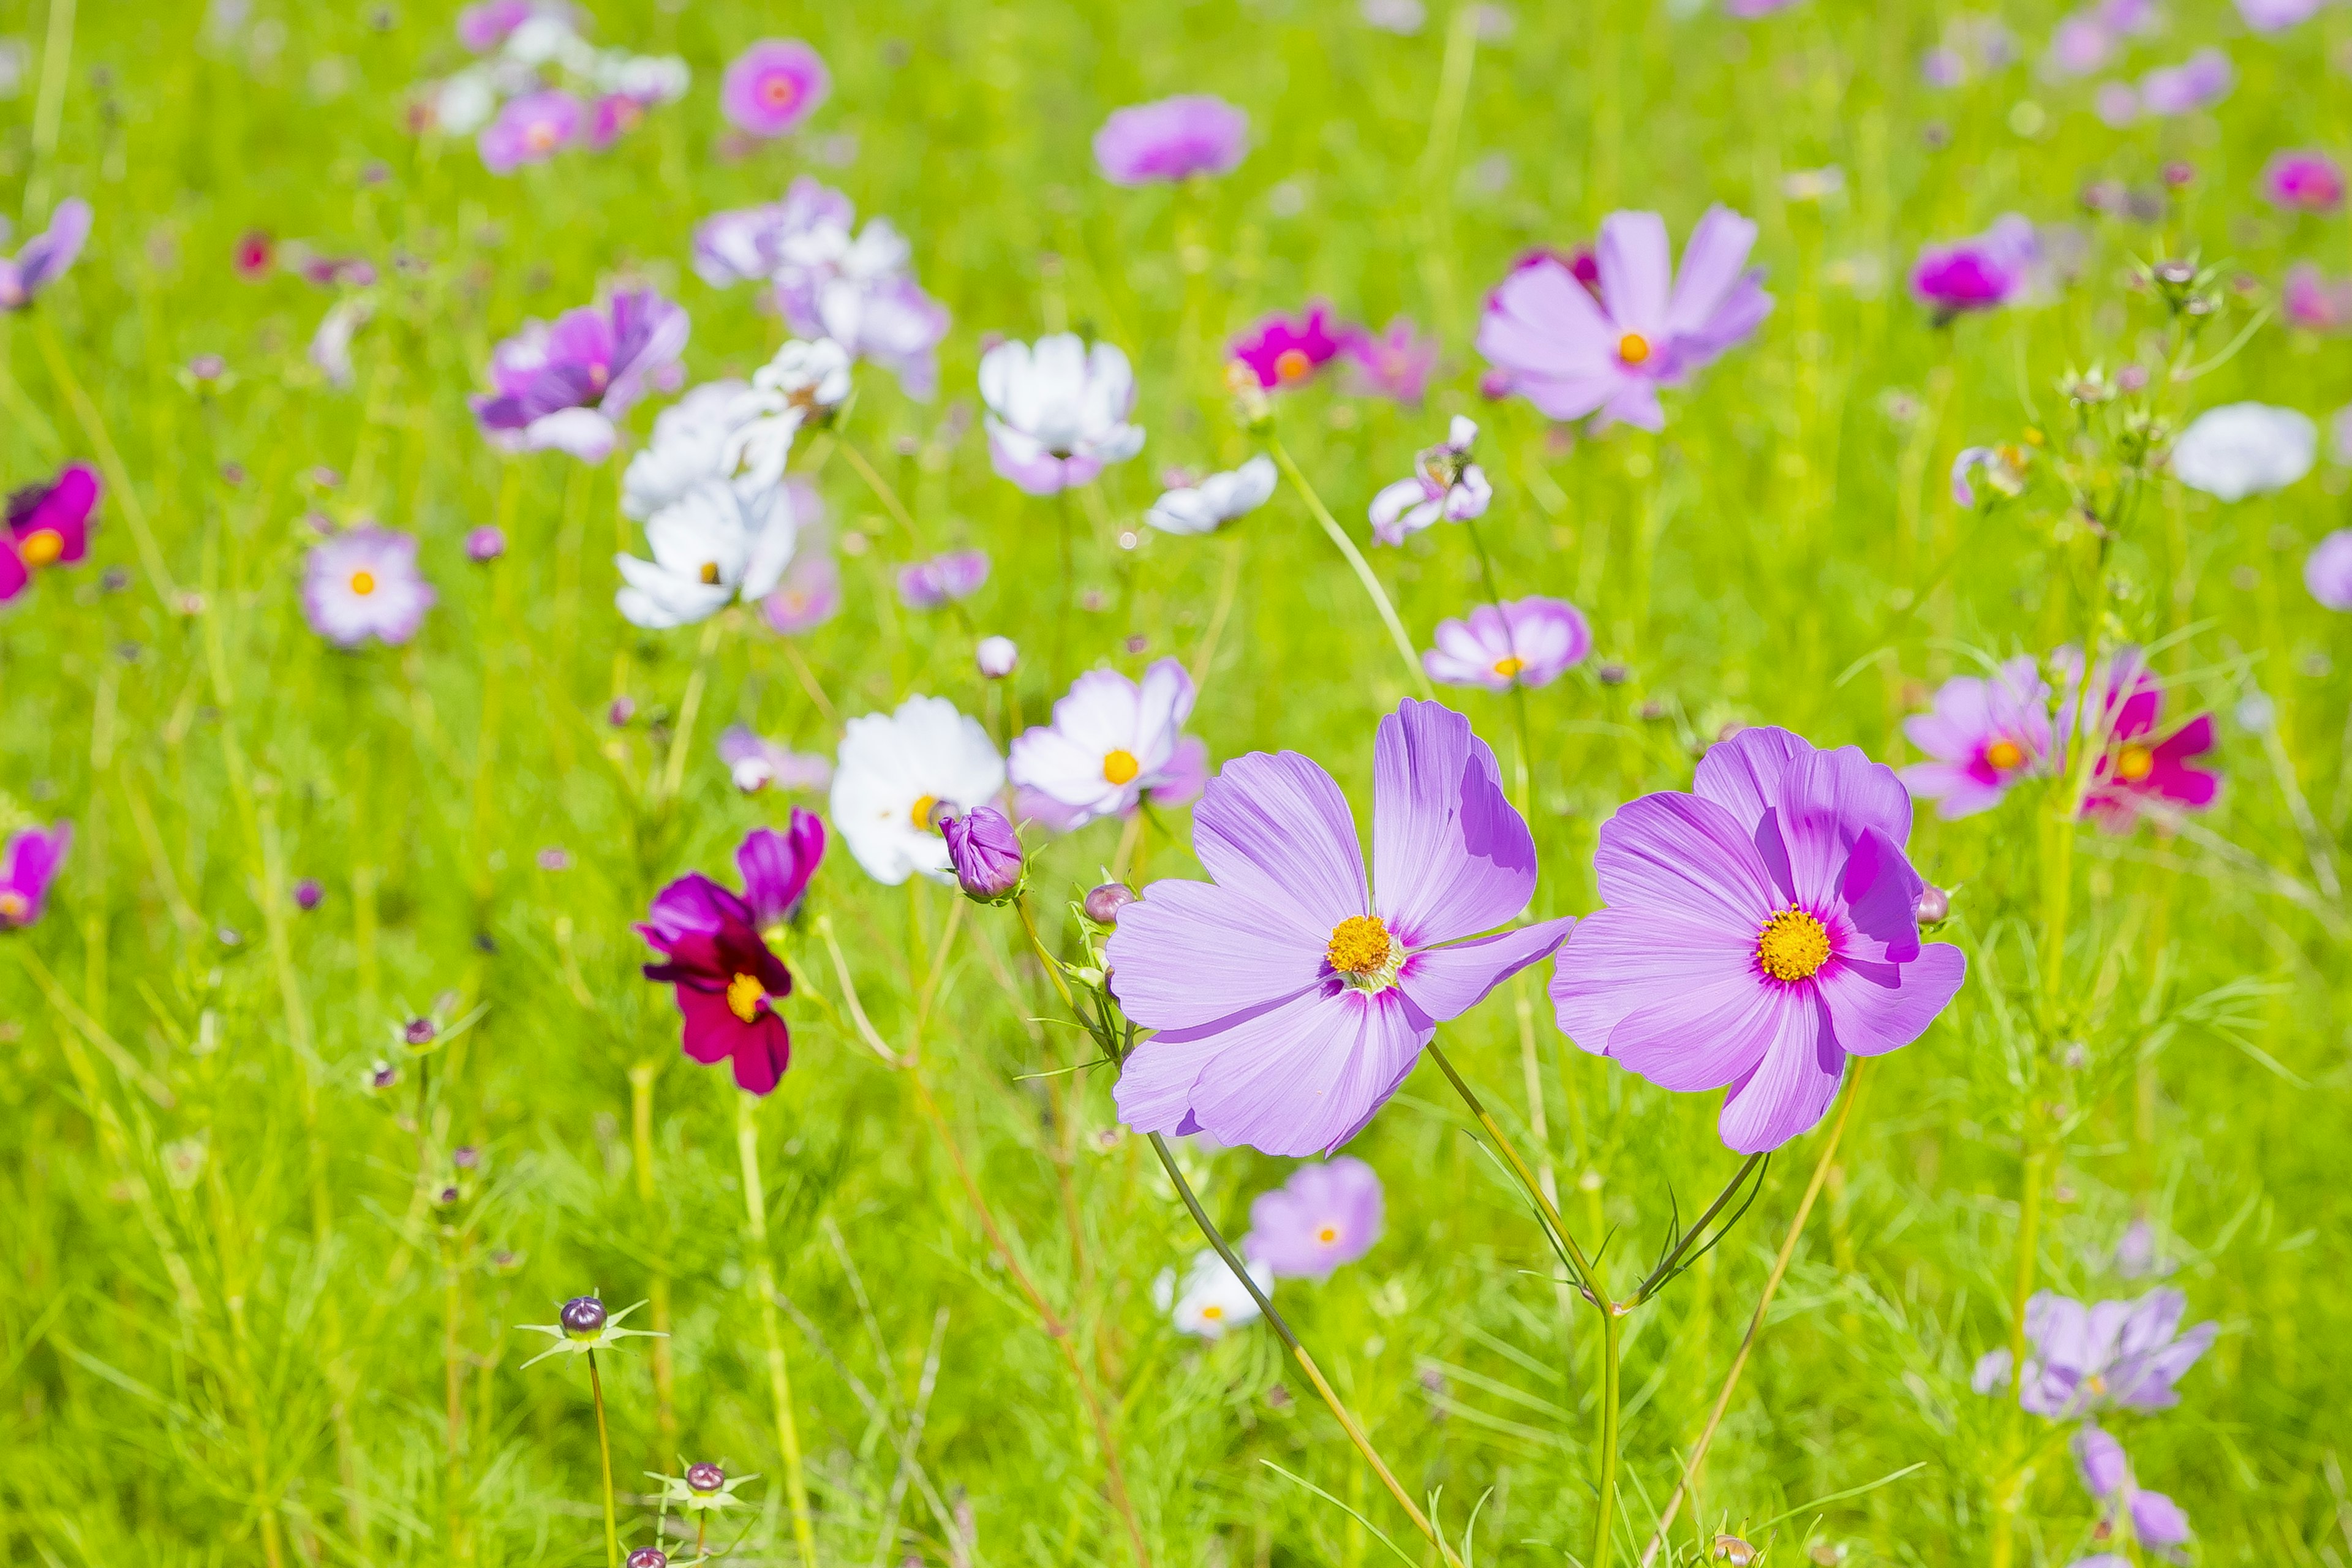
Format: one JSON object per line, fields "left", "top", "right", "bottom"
{"left": 831, "top": 696, "right": 1005, "bottom": 886}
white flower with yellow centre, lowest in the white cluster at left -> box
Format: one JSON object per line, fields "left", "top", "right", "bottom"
{"left": 614, "top": 480, "right": 797, "bottom": 630}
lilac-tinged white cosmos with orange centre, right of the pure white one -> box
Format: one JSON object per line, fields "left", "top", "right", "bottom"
{"left": 1007, "top": 658, "right": 1207, "bottom": 832}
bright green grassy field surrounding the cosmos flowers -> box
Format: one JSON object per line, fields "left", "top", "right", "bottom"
{"left": 0, "top": 0, "right": 2352, "bottom": 1568}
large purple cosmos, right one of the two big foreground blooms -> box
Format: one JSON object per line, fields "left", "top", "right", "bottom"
{"left": 1552, "top": 729, "right": 1966, "bottom": 1154}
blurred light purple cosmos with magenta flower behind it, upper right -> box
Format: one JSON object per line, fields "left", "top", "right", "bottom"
{"left": 1477, "top": 207, "right": 1771, "bottom": 430}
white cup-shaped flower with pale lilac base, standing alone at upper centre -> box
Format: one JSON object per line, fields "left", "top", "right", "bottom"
{"left": 981, "top": 331, "right": 1143, "bottom": 496}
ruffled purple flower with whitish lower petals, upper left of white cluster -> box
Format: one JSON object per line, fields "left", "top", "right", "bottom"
{"left": 470, "top": 289, "right": 692, "bottom": 463}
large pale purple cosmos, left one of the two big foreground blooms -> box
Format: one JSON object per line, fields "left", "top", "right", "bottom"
{"left": 1108, "top": 701, "right": 1574, "bottom": 1154}
